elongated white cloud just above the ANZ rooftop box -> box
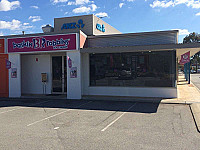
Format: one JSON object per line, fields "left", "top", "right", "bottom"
{"left": 72, "top": 4, "right": 97, "bottom": 14}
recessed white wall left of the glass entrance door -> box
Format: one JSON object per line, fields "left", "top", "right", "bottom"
{"left": 21, "top": 55, "right": 52, "bottom": 94}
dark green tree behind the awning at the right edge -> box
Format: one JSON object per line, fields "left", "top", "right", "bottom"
{"left": 183, "top": 32, "right": 200, "bottom": 72}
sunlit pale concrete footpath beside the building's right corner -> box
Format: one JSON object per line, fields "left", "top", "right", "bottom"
{"left": 161, "top": 74, "right": 200, "bottom": 132}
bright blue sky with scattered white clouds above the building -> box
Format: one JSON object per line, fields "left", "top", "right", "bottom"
{"left": 0, "top": 0, "right": 200, "bottom": 42}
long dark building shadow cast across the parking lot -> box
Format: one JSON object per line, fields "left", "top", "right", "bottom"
{"left": 0, "top": 99, "right": 160, "bottom": 113}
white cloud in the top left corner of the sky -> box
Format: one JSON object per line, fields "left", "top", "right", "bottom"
{"left": 0, "top": 0, "right": 20, "bottom": 11}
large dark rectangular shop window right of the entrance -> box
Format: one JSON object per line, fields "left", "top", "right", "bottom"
{"left": 90, "top": 51, "right": 176, "bottom": 87}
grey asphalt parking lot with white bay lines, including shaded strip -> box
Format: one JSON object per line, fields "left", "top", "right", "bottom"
{"left": 0, "top": 99, "right": 200, "bottom": 150}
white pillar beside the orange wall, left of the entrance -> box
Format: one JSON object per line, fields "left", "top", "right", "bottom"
{"left": 8, "top": 54, "right": 21, "bottom": 97}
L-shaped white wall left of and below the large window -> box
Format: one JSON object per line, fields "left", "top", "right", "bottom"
{"left": 82, "top": 54, "right": 177, "bottom": 98}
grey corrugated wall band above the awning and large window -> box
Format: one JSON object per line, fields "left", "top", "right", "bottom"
{"left": 87, "top": 31, "right": 178, "bottom": 47}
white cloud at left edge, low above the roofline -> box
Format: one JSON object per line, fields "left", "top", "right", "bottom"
{"left": 0, "top": 19, "right": 33, "bottom": 30}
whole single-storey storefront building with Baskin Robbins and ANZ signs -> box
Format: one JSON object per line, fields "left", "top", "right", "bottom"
{"left": 0, "top": 15, "right": 200, "bottom": 99}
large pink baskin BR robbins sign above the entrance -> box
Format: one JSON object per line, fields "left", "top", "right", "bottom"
{"left": 8, "top": 34, "right": 76, "bottom": 53}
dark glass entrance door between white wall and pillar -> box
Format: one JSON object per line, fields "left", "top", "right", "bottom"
{"left": 52, "top": 56, "right": 67, "bottom": 94}
